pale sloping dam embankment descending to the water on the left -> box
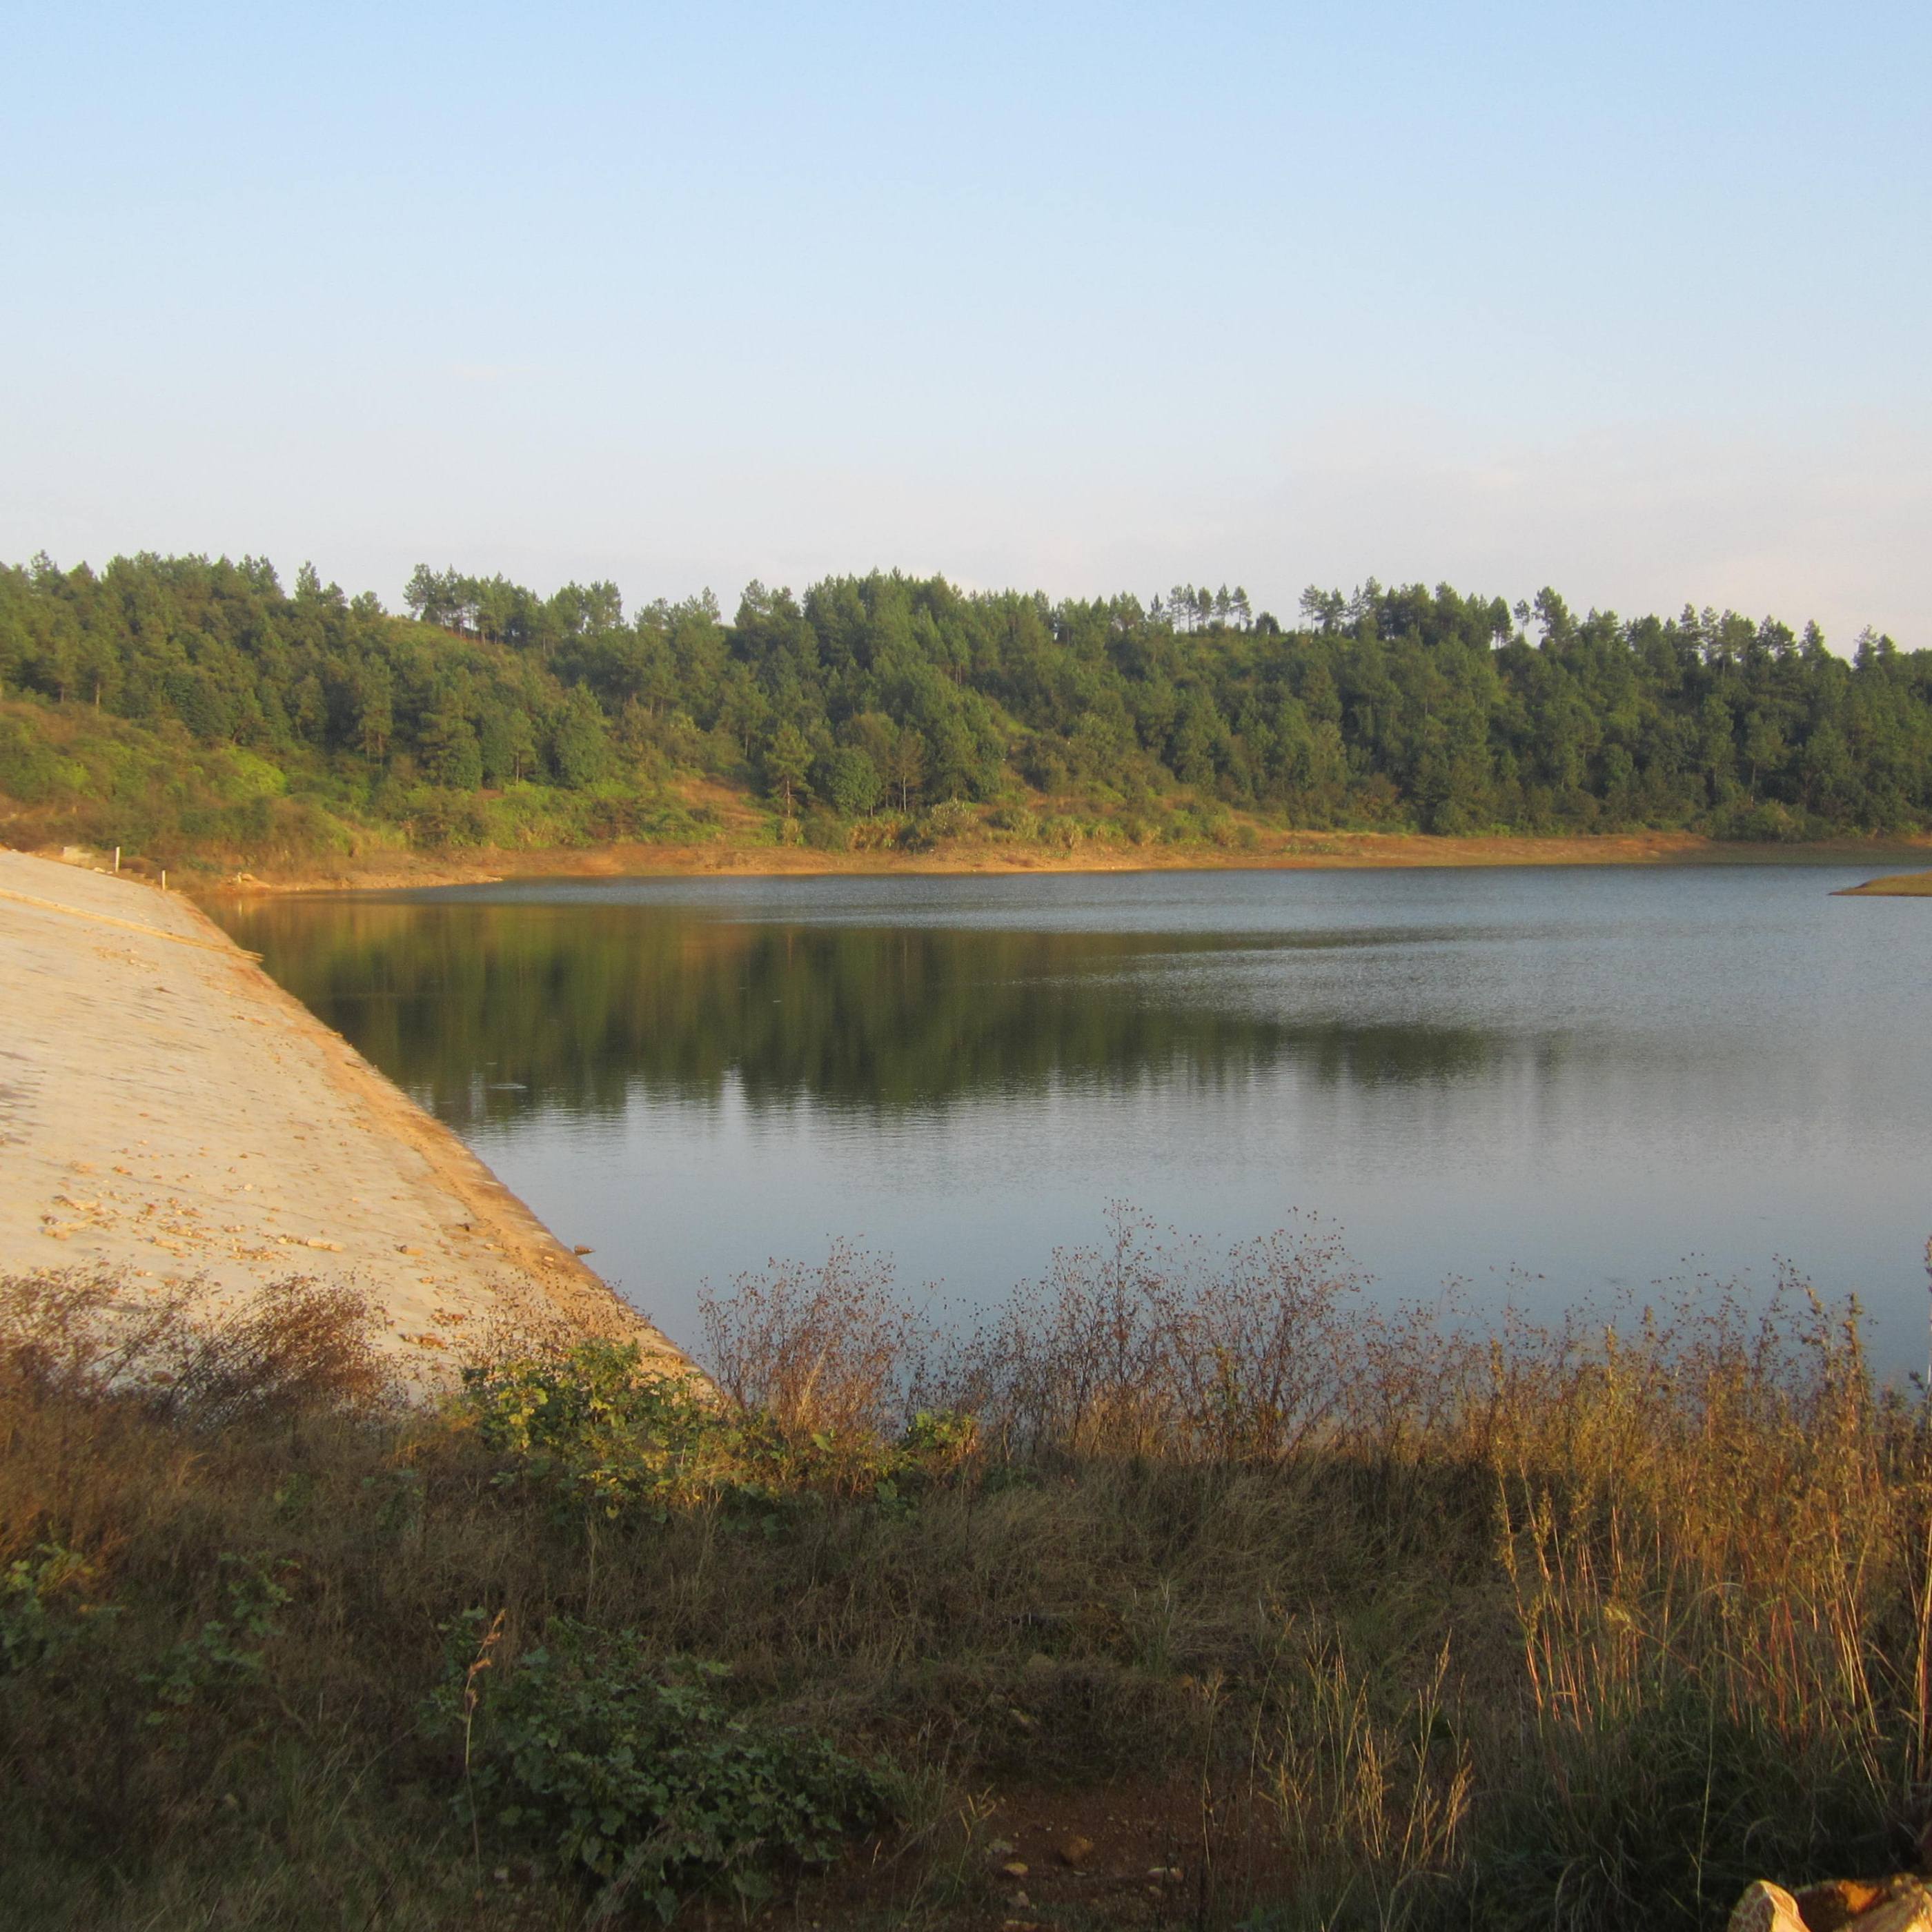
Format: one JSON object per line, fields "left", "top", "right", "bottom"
{"left": 0, "top": 852, "right": 682, "bottom": 1383}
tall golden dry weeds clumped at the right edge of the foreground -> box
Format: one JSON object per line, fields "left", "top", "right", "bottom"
{"left": 1460, "top": 1281, "right": 1932, "bottom": 1926}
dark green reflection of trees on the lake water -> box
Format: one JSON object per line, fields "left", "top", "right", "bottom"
{"left": 224, "top": 900, "right": 1507, "bottom": 1130}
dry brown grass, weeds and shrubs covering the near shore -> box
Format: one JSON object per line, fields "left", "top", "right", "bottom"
{"left": 0, "top": 1219, "right": 1932, "bottom": 1932}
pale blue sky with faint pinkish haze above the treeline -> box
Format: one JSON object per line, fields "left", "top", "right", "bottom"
{"left": 0, "top": 0, "right": 1932, "bottom": 647}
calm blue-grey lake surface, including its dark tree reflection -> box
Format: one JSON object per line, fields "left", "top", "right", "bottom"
{"left": 218, "top": 865, "right": 1932, "bottom": 1368}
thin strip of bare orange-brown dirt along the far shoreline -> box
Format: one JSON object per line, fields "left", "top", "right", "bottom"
{"left": 146, "top": 833, "right": 1932, "bottom": 894}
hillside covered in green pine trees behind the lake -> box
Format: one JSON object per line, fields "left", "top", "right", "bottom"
{"left": 0, "top": 555, "right": 1932, "bottom": 869}
